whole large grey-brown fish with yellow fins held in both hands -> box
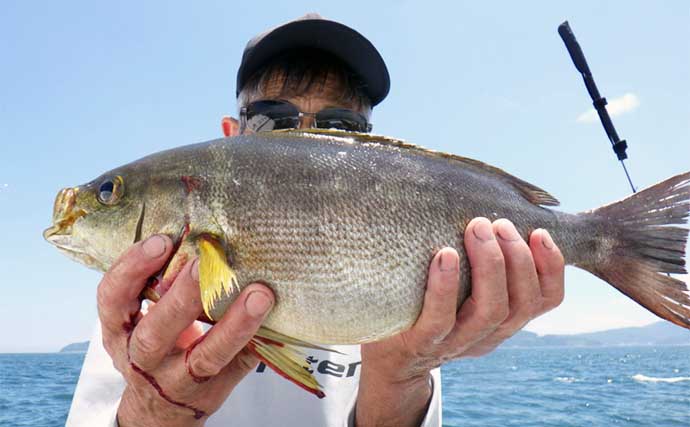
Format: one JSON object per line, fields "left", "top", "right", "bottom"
{"left": 44, "top": 129, "right": 690, "bottom": 397}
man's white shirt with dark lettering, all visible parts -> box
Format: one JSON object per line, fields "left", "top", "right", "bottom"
{"left": 66, "top": 324, "right": 441, "bottom": 427}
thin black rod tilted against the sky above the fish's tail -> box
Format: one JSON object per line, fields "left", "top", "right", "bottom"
{"left": 558, "top": 21, "right": 637, "bottom": 193}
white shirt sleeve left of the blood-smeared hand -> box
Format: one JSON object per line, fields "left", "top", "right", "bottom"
{"left": 65, "top": 322, "right": 125, "bottom": 427}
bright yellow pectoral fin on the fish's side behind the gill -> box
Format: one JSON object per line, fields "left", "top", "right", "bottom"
{"left": 199, "top": 236, "right": 240, "bottom": 320}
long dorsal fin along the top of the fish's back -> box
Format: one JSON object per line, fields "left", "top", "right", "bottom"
{"left": 271, "top": 129, "right": 559, "bottom": 206}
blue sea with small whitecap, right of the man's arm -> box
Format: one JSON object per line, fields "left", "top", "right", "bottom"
{"left": 443, "top": 346, "right": 690, "bottom": 427}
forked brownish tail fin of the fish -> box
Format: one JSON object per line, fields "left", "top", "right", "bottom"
{"left": 588, "top": 172, "right": 690, "bottom": 329}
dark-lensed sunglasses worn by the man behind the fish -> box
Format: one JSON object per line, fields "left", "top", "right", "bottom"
{"left": 240, "top": 100, "right": 372, "bottom": 132}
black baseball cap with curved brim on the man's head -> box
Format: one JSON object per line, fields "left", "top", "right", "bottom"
{"left": 235, "top": 13, "right": 390, "bottom": 106}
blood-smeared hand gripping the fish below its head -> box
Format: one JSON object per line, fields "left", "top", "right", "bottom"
{"left": 98, "top": 236, "right": 274, "bottom": 427}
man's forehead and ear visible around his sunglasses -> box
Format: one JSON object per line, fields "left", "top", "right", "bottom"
{"left": 224, "top": 73, "right": 371, "bottom": 136}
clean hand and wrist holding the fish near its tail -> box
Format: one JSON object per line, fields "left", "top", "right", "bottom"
{"left": 356, "top": 218, "right": 564, "bottom": 426}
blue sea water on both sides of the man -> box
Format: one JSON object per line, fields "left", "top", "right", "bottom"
{"left": 0, "top": 347, "right": 690, "bottom": 427}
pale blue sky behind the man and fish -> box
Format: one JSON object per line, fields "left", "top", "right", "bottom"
{"left": 0, "top": 0, "right": 690, "bottom": 352}
